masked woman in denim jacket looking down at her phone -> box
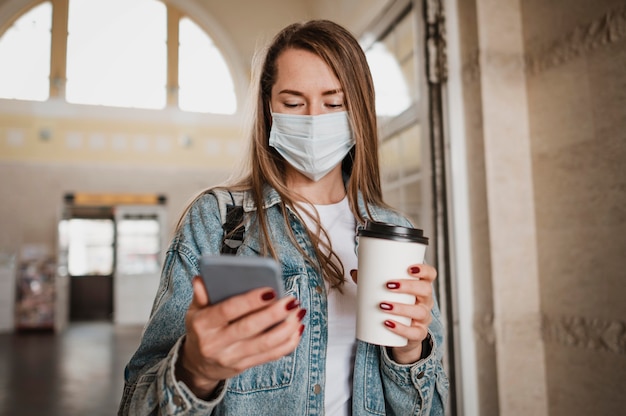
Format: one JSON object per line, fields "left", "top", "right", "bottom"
{"left": 120, "top": 21, "right": 448, "bottom": 416}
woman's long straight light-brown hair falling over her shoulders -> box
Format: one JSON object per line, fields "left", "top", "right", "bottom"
{"left": 182, "top": 20, "right": 385, "bottom": 290}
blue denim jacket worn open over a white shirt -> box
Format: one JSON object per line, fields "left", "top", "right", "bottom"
{"left": 119, "top": 187, "right": 448, "bottom": 416}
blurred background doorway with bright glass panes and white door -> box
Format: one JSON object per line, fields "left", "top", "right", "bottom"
{"left": 57, "top": 193, "right": 165, "bottom": 327}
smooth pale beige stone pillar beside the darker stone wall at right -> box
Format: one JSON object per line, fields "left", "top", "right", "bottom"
{"left": 476, "top": 0, "right": 548, "bottom": 416}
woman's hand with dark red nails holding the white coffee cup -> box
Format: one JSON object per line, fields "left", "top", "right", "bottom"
{"left": 350, "top": 264, "right": 437, "bottom": 364}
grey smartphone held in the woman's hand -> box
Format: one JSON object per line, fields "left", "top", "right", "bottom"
{"left": 200, "top": 255, "right": 285, "bottom": 304}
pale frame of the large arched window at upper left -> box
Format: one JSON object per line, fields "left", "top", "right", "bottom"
{"left": 0, "top": 0, "right": 248, "bottom": 119}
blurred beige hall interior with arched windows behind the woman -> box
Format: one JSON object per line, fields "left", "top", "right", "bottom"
{"left": 0, "top": 0, "right": 626, "bottom": 415}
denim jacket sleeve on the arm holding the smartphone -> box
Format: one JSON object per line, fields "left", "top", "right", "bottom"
{"left": 118, "top": 196, "right": 226, "bottom": 415}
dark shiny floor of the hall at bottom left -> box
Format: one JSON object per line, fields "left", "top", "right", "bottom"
{"left": 0, "top": 322, "right": 141, "bottom": 416}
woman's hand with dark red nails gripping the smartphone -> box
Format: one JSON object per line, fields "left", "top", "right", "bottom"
{"left": 176, "top": 277, "right": 306, "bottom": 398}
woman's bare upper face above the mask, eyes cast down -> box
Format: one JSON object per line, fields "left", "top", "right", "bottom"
{"left": 270, "top": 49, "right": 346, "bottom": 116}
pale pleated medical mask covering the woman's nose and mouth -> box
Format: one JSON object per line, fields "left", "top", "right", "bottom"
{"left": 269, "top": 111, "right": 354, "bottom": 181}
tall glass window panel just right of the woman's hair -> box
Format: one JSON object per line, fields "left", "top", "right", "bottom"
{"left": 362, "top": 7, "right": 430, "bottom": 224}
